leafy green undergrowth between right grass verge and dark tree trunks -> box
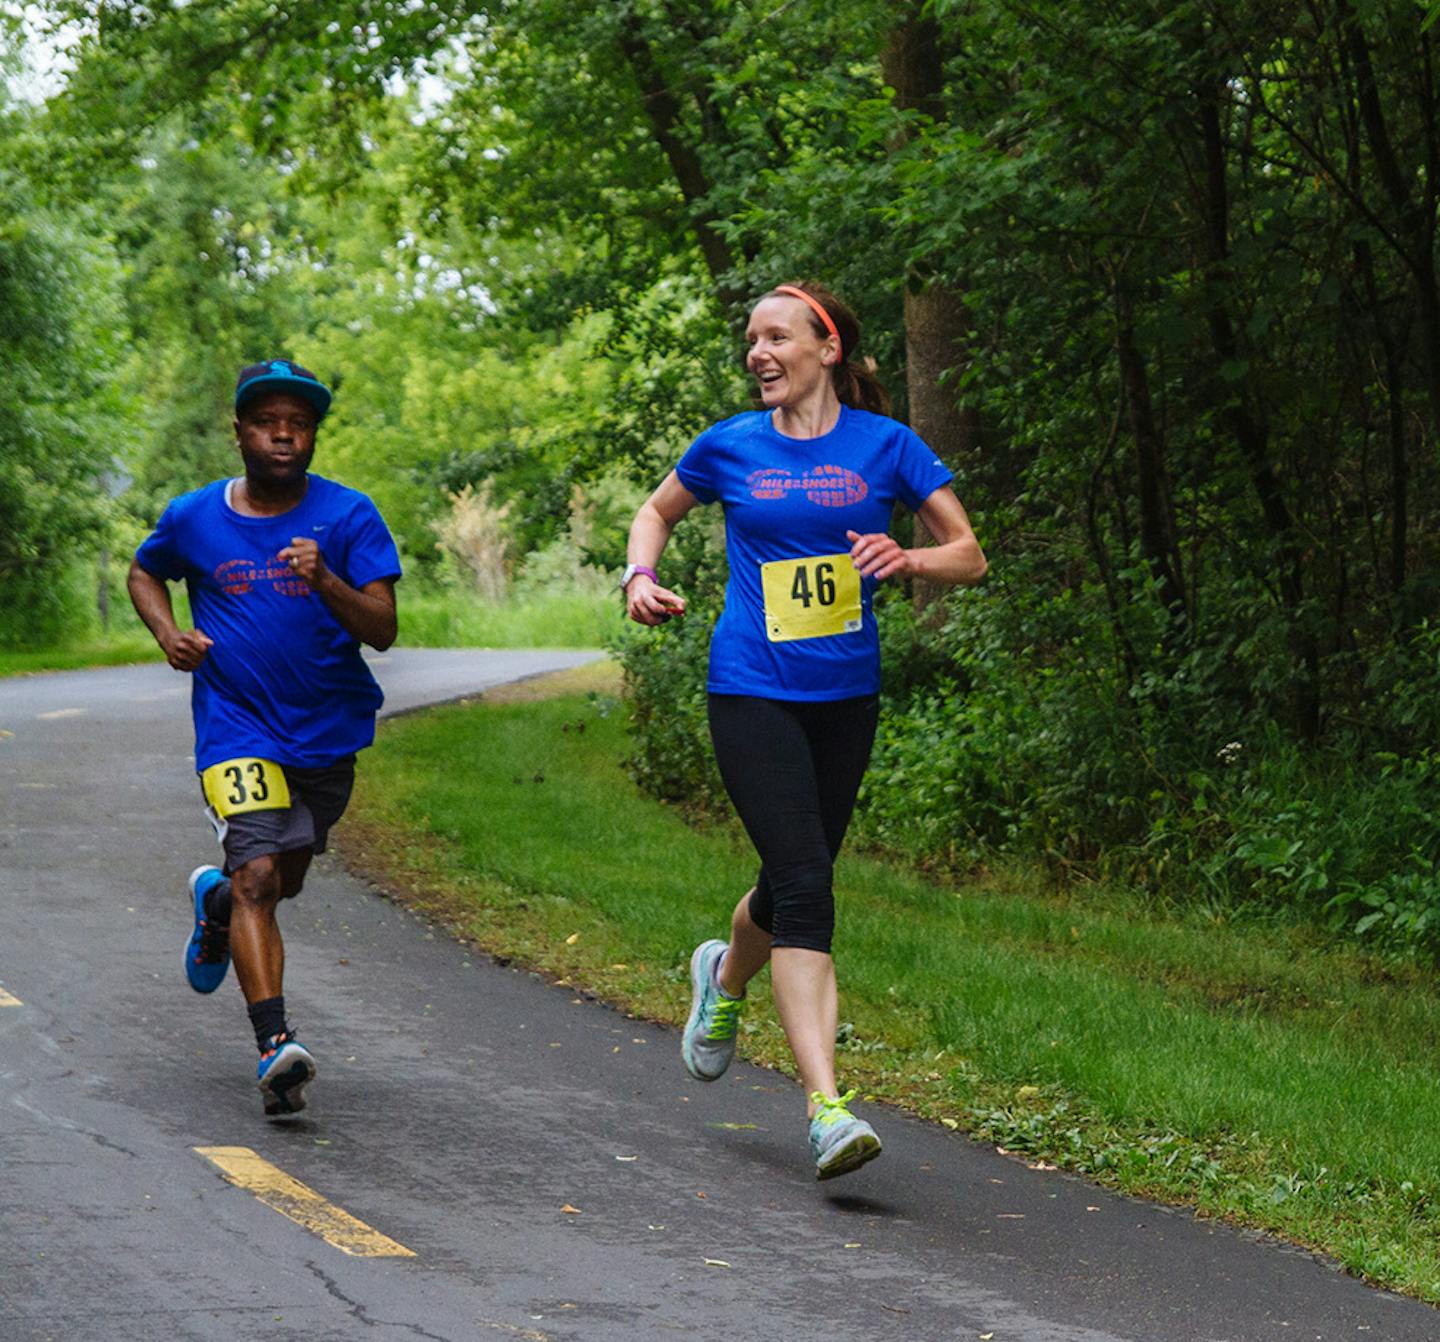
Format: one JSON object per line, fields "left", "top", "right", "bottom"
{"left": 622, "top": 515, "right": 1440, "bottom": 952}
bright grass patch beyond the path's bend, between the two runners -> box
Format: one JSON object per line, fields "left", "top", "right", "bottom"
{"left": 399, "top": 583, "right": 621, "bottom": 648}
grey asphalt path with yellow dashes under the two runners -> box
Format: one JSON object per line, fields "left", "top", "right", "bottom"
{"left": 0, "top": 651, "right": 1440, "bottom": 1342}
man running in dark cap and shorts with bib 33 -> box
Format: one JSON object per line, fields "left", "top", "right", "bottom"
{"left": 130, "top": 359, "right": 400, "bottom": 1117}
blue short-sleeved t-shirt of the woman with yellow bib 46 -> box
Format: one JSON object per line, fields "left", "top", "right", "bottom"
{"left": 675, "top": 406, "right": 952, "bottom": 700}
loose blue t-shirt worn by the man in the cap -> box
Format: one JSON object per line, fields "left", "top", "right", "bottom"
{"left": 135, "top": 475, "right": 400, "bottom": 770}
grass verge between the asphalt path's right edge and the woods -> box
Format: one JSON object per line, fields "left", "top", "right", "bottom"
{"left": 341, "top": 670, "right": 1440, "bottom": 1300}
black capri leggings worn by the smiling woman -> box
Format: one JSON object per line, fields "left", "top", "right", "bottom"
{"left": 710, "top": 694, "right": 880, "bottom": 953}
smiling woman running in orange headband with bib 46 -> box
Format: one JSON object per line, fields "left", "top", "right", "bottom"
{"left": 622, "top": 284, "right": 985, "bottom": 1179}
